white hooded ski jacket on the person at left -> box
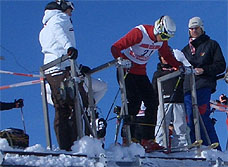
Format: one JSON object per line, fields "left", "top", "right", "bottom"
{"left": 39, "top": 10, "right": 76, "bottom": 72}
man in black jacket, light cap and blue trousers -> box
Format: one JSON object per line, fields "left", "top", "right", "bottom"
{"left": 182, "top": 17, "right": 226, "bottom": 150}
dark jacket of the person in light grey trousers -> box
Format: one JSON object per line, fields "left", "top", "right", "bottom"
{"left": 152, "top": 63, "right": 184, "bottom": 103}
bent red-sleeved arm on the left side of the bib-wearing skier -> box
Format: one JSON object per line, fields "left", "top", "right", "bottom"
{"left": 111, "top": 28, "right": 143, "bottom": 58}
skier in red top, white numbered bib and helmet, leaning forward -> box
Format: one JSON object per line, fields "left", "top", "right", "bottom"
{"left": 111, "top": 16, "right": 181, "bottom": 152}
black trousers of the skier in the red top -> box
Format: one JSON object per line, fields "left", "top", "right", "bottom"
{"left": 125, "top": 73, "right": 157, "bottom": 140}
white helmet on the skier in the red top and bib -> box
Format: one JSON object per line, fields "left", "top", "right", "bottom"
{"left": 154, "top": 16, "right": 176, "bottom": 38}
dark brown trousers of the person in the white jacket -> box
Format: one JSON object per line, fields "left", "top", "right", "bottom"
{"left": 46, "top": 71, "right": 78, "bottom": 151}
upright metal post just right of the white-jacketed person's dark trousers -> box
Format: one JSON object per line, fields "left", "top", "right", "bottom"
{"left": 70, "top": 59, "right": 83, "bottom": 139}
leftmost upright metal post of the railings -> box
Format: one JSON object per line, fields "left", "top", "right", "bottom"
{"left": 40, "top": 68, "right": 52, "bottom": 150}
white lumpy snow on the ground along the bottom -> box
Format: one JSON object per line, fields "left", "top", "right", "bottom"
{"left": 0, "top": 136, "right": 228, "bottom": 167}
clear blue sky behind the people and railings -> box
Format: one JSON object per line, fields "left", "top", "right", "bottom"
{"left": 0, "top": 0, "right": 228, "bottom": 149}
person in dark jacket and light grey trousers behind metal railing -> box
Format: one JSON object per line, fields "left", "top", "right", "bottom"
{"left": 152, "top": 51, "right": 188, "bottom": 147}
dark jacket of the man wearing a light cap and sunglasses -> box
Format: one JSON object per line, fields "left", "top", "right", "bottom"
{"left": 182, "top": 34, "right": 226, "bottom": 93}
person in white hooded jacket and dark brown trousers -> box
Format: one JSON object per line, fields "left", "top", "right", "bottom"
{"left": 39, "top": 0, "right": 107, "bottom": 151}
